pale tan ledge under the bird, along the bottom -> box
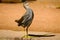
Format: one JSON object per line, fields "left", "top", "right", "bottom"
{"left": 0, "top": 30, "right": 60, "bottom": 40}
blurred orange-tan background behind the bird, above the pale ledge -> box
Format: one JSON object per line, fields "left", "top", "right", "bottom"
{"left": 0, "top": 0, "right": 60, "bottom": 33}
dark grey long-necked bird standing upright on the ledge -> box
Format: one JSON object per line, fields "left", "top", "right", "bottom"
{"left": 15, "top": 2, "right": 34, "bottom": 35}
